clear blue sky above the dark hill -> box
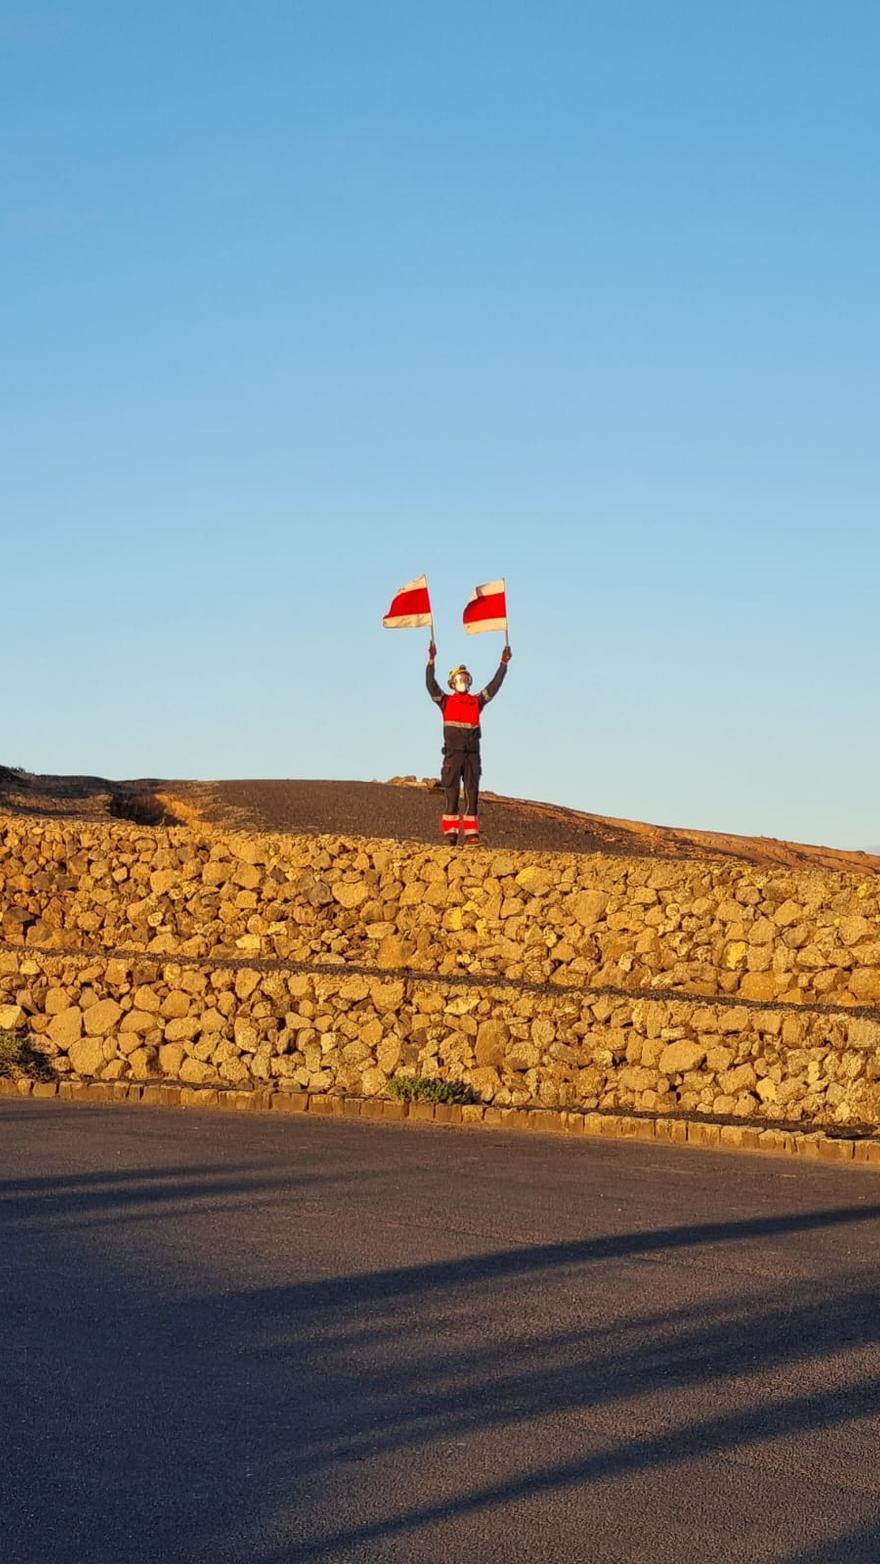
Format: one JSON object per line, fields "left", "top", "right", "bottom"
{"left": 0, "top": 0, "right": 880, "bottom": 846}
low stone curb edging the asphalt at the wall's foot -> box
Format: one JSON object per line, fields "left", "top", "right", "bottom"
{"left": 0, "top": 1078, "right": 880, "bottom": 1168}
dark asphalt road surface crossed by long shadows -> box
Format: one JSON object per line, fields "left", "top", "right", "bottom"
{"left": 0, "top": 1101, "right": 880, "bottom": 1564}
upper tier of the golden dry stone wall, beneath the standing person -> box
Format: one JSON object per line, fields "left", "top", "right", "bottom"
{"left": 0, "top": 820, "right": 880, "bottom": 1006}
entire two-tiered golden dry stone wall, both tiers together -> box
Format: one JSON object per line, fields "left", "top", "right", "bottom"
{"left": 0, "top": 818, "right": 880, "bottom": 1125}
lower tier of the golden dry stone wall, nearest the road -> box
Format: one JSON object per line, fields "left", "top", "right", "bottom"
{"left": 0, "top": 949, "right": 880, "bottom": 1123}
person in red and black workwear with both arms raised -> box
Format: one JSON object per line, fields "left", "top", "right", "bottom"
{"left": 425, "top": 641, "right": 513, "bottom": 848}
